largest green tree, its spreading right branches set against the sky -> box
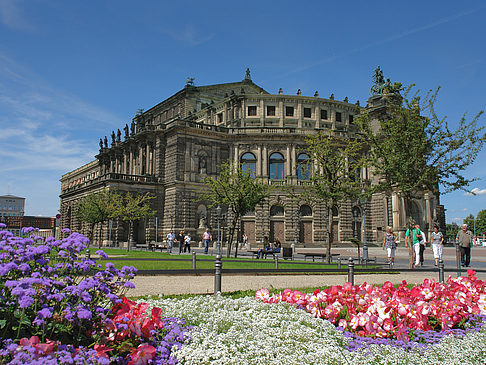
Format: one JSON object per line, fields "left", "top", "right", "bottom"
{"left": 355, "top": 85, "right": 486, "bottom": 265}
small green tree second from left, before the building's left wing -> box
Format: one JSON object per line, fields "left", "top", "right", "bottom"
{"left": 114, "top": 193, "right": 155, "bottom": 251}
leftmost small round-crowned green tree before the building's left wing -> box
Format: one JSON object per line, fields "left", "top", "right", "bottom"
{"left": 76, "top": 190, "right": 119, "bottom": 247}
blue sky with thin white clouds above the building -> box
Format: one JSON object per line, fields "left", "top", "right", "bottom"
{"left": 0, "top": 0, "right": 486, "bottom": 222}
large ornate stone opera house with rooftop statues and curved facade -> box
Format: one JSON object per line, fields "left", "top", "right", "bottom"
{"left": 60, "top": 70, "right": 445, "bottom": 246}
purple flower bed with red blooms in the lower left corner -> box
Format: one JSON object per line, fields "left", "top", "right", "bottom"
{"left": 0, "top": 226, "right": 191, "bottom": 364}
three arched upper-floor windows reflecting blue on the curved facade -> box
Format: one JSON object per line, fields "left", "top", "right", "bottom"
{"left": 240, "top": 152, "right": 311, "bottom": 180}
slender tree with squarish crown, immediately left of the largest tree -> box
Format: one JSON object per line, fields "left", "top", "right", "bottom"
{"left": 306, "top": 133, "right": 364, "bottom": 263}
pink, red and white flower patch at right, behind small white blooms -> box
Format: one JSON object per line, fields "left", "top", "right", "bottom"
{"left": 256, "top": 270, "right": 486, "bottom": 341}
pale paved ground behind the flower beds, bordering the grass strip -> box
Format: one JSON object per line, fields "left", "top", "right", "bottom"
{"left": 127, "top": 247, "right": 486, "bottom": 296}
